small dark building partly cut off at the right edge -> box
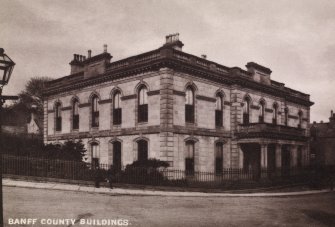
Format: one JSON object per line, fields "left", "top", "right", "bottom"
{"left": 310, "top": 111, "right": 335, "bottom": 166}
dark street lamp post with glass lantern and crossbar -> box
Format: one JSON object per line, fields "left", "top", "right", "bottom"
{"left": 0, "top": 48, "right": 18, "bottom": 226}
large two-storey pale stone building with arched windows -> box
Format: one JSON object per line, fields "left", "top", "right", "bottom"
{"left": 44, "top": 34, "right": 313, "bottom": 174}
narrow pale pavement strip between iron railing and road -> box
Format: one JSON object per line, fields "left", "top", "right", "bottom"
{"left": 2, "top": 178, "right": 333, "bottom": 197}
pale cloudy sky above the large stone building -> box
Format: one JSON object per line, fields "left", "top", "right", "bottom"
{"left": 0, "top": 0, "right": 335, "bottom": 122}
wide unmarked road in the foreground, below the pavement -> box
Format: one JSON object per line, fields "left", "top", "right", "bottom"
{"left": 3, "top": 187, "right": 335, "bottom": 227}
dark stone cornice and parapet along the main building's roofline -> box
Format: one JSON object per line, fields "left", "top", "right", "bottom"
{"left": 44, "top": 49, "right": 313, "bottom": 106}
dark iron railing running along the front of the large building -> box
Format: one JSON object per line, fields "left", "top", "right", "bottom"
{"left": 2, "top": 155, "right": 322, "bottom": 187}
